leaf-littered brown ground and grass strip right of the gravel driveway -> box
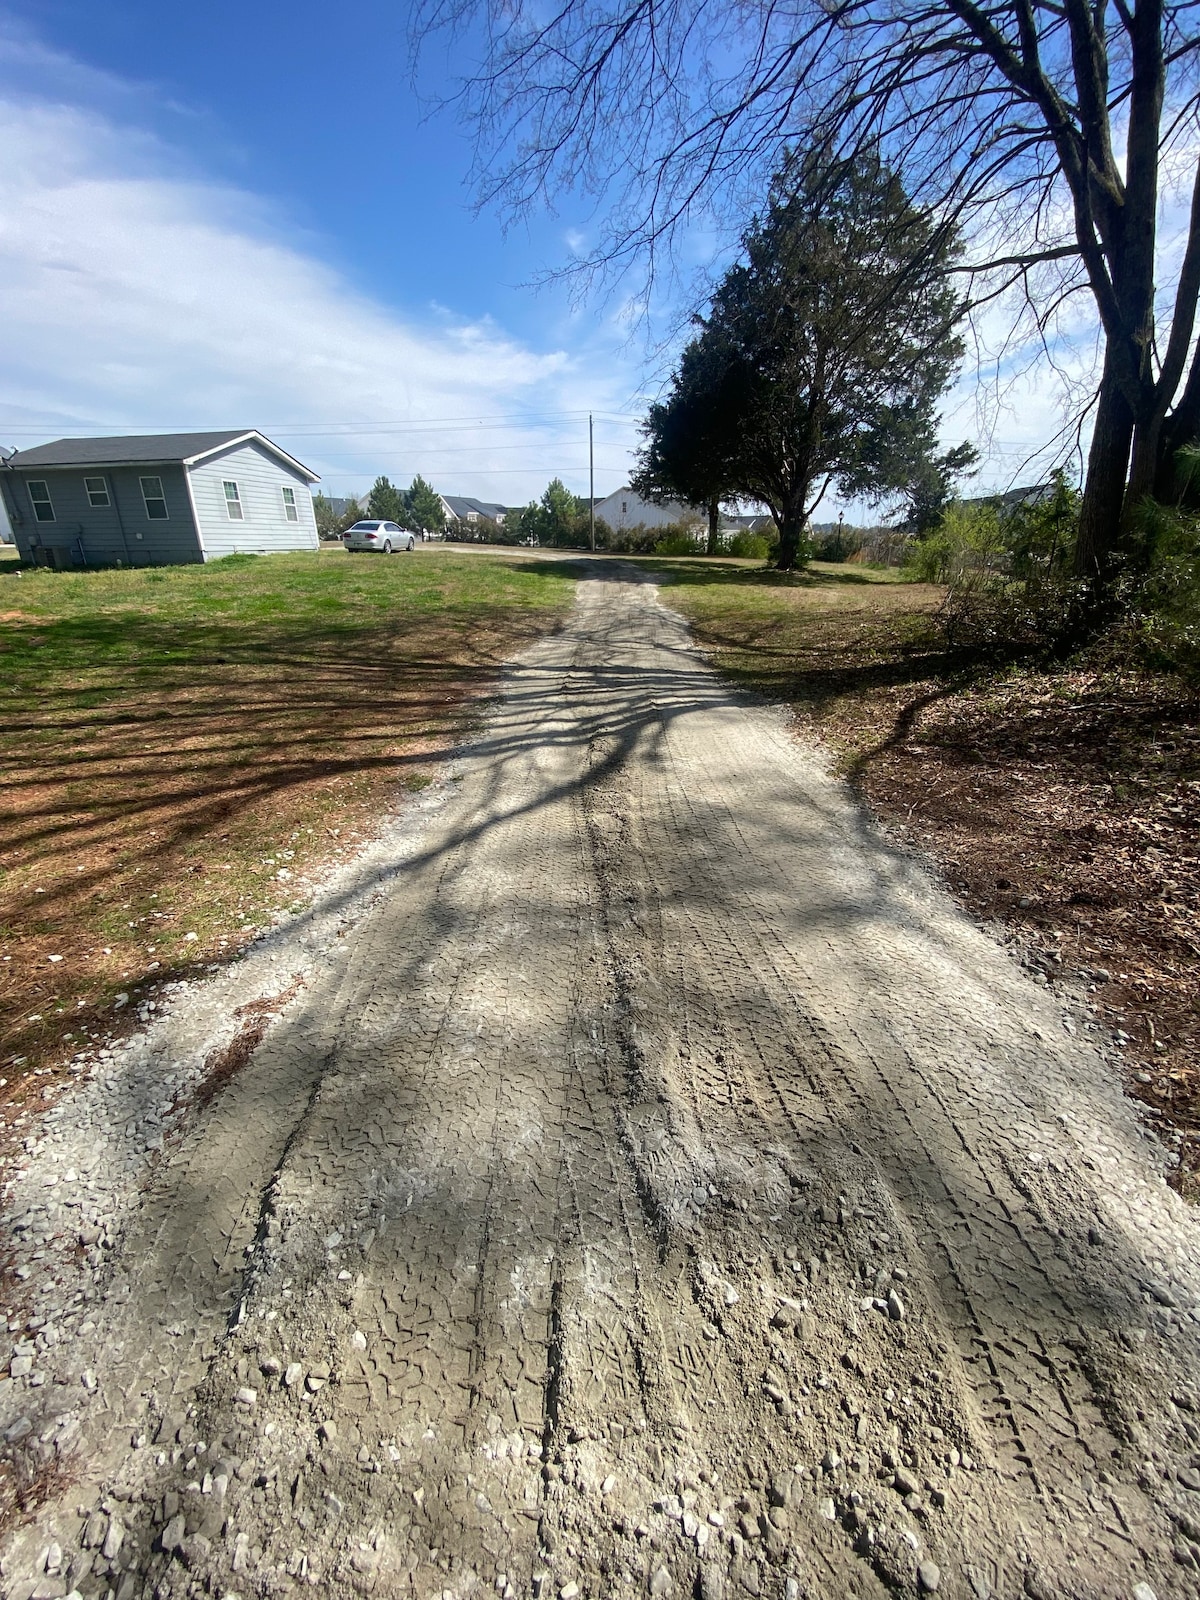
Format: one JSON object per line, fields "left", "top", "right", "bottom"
{"left": 656, "top": 562, "right": 1200, "bottom": 1200}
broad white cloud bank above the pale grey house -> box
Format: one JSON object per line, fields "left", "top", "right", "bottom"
{"left": 0, "top": 98, "right": 635, "bottom": 502}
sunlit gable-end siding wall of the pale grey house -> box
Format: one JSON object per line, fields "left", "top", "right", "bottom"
{"left": 189, "top": 442, "right": 320, "bottom": 562}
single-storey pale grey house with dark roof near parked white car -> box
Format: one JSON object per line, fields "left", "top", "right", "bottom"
{"left": 0, "top": 427, "right": 318, "bottom": 568}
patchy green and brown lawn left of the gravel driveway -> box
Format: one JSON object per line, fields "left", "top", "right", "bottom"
{"left": 0, "top": 546, "right": 573, "bottom": 1102}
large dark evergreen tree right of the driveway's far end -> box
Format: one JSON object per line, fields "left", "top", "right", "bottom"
{"left": 643, "top": 150, "right": 963, "bottom": 568}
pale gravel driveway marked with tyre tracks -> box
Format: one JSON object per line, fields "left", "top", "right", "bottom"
{"left": 3, "top": 565, "right": 1200, "bottom": 1600}
